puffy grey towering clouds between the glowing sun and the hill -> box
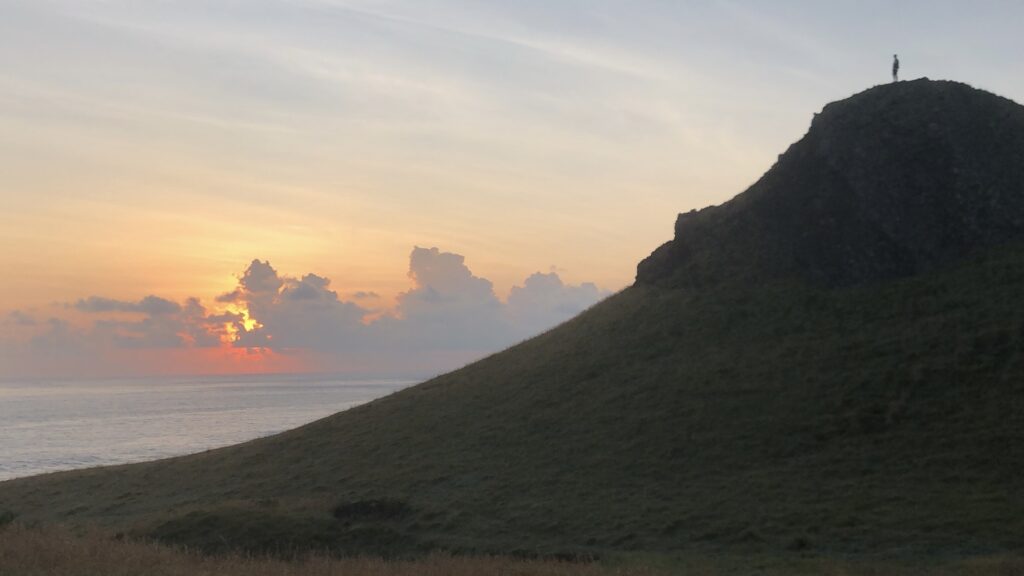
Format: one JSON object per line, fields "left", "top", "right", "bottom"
{"left": 220, "top": 246, "right": 608, "bottom": 359}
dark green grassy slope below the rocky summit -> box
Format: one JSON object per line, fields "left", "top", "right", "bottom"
{"left": 0, "top": 240, "right": 1024, "bottom": 565}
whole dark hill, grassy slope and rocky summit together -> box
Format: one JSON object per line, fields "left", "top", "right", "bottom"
{"left": 0, "top": 80, "right": 1024, "bottom": 559}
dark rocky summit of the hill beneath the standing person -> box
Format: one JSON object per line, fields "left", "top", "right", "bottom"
{"left": 637, "top": 79, "right": 1024, "bottom": 285}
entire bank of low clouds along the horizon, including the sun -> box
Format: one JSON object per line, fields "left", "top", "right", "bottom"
{"left": 0, "top": 247, "right": 608, "bottom": 373}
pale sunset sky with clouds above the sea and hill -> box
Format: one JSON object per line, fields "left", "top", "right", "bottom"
{"left": 0, "top": 0, "right": 1024, "bottom": 378}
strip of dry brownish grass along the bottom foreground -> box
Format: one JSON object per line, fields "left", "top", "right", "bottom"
{"left": 0, "top": 526, "right": 1024, "bottom": 576}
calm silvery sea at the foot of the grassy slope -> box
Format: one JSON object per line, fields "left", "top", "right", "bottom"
{"left": 0, "top": 375, "right": 414, "bottom": 481}
